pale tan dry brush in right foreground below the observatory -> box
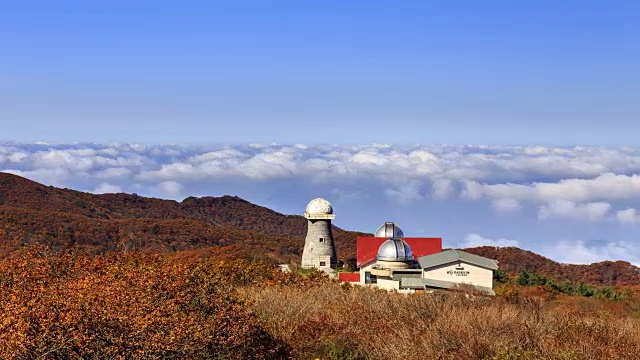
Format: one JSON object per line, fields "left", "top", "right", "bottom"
{"left": 243, "top": 284, "right": 640, "bottom": 359}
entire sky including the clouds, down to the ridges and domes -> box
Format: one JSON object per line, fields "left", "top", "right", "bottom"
{"left": 0, "top": 0, "right": 640, "bottom": 264}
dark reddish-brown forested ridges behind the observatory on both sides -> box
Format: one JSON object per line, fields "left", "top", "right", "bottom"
{"left": 0, "top": 172, "right": 640, "bottom": 285}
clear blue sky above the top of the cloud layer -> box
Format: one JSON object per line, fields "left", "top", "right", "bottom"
{"left": 0, "top": 1, "right": 640, "bottom": 146}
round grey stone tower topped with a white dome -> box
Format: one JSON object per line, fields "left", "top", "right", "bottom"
{"left": 302, "top": 198, "right": 337, "bottom": 270}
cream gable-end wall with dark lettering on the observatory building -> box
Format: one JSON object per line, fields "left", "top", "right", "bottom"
{"left": 422, "top": 261, "right": 493, "bottom": 289}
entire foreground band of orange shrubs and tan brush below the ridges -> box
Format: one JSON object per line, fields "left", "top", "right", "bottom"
{"left": 0, "top": 246, "right": 640, "bottom": 359}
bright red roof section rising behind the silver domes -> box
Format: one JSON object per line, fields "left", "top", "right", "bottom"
{"left": 356, "top": 236, "right": 442, "bottom": 267}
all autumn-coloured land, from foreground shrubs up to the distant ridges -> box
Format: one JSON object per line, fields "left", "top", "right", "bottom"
{"left": 0, "top": 173, "right": 640, "bottom": 360}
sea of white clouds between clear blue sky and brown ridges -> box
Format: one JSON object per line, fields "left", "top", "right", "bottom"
{"left": 0, "top": 143, "right": 640, "bottom": 264}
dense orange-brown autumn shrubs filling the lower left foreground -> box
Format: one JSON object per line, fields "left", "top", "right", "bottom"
{"left": 0, "top": 251, "right": 287, "bottom": 359}
